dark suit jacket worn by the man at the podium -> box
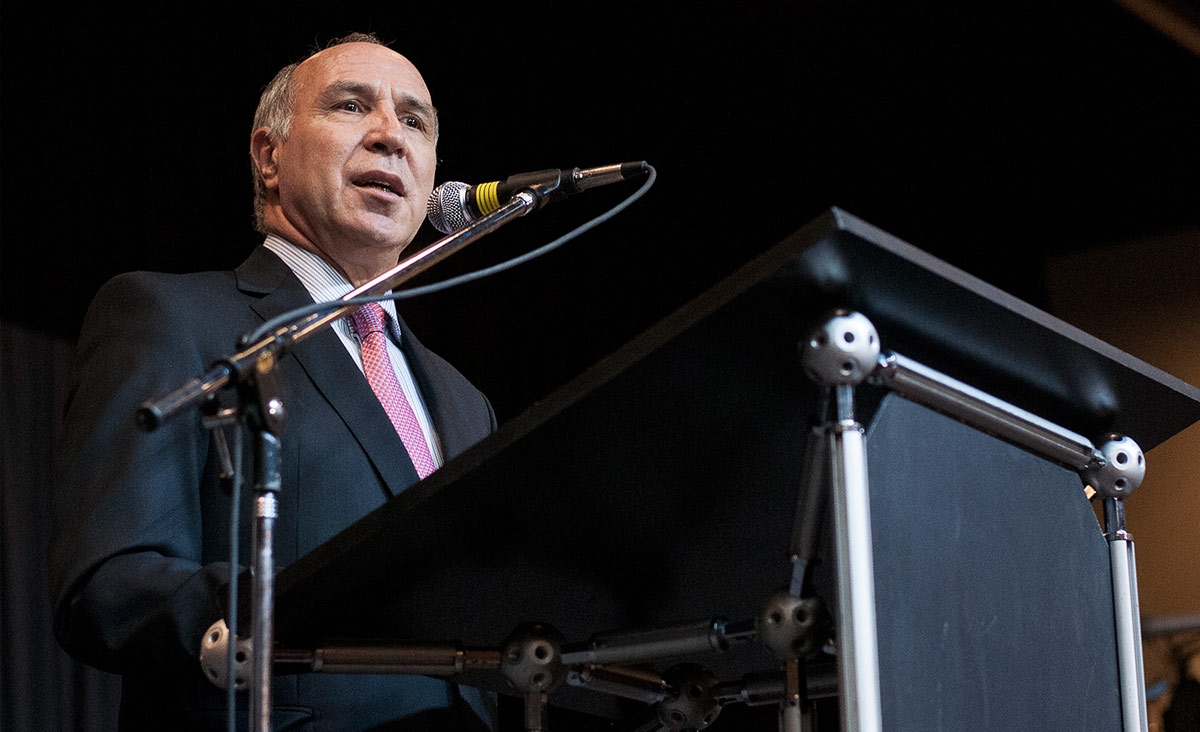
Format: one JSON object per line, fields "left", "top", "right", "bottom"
{"left": 50, "top": 246, "right": 496, "bottom": 732}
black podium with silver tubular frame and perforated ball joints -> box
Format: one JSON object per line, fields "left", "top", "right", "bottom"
{"left": 267, "top": 210, "right": 1200, "bottom": 732}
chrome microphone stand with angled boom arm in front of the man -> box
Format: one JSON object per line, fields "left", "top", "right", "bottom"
{"left": 137, "top": 186, "right": 537, "bottom": 732}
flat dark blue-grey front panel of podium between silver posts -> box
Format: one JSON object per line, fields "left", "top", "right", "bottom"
{"left": 868, "top": 396, "right": 1121, "bottom": 732}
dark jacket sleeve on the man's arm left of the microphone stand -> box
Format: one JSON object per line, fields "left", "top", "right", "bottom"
{"left": 49, "top": 274, "right": 236, "bottom": 673}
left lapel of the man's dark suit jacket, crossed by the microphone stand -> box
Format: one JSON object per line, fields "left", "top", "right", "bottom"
{"left": 238, "top": 247, "right": 418, "bottom": 496}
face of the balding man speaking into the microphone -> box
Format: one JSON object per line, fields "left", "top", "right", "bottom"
{"left": 268, "top": 43, "right": 437, "bottom": 260}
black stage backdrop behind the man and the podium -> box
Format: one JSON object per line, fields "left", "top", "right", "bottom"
{"left": 0, "top": 0, "right": 1200, "bottom": 732}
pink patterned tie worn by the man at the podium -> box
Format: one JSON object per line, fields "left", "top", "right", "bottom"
{"left": 352, "top": 302, "right": 437, "bottom": 478}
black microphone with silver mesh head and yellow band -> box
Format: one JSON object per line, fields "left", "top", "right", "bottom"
{"left": 426, "top": 161, "right": 649, "bottom": 234}
